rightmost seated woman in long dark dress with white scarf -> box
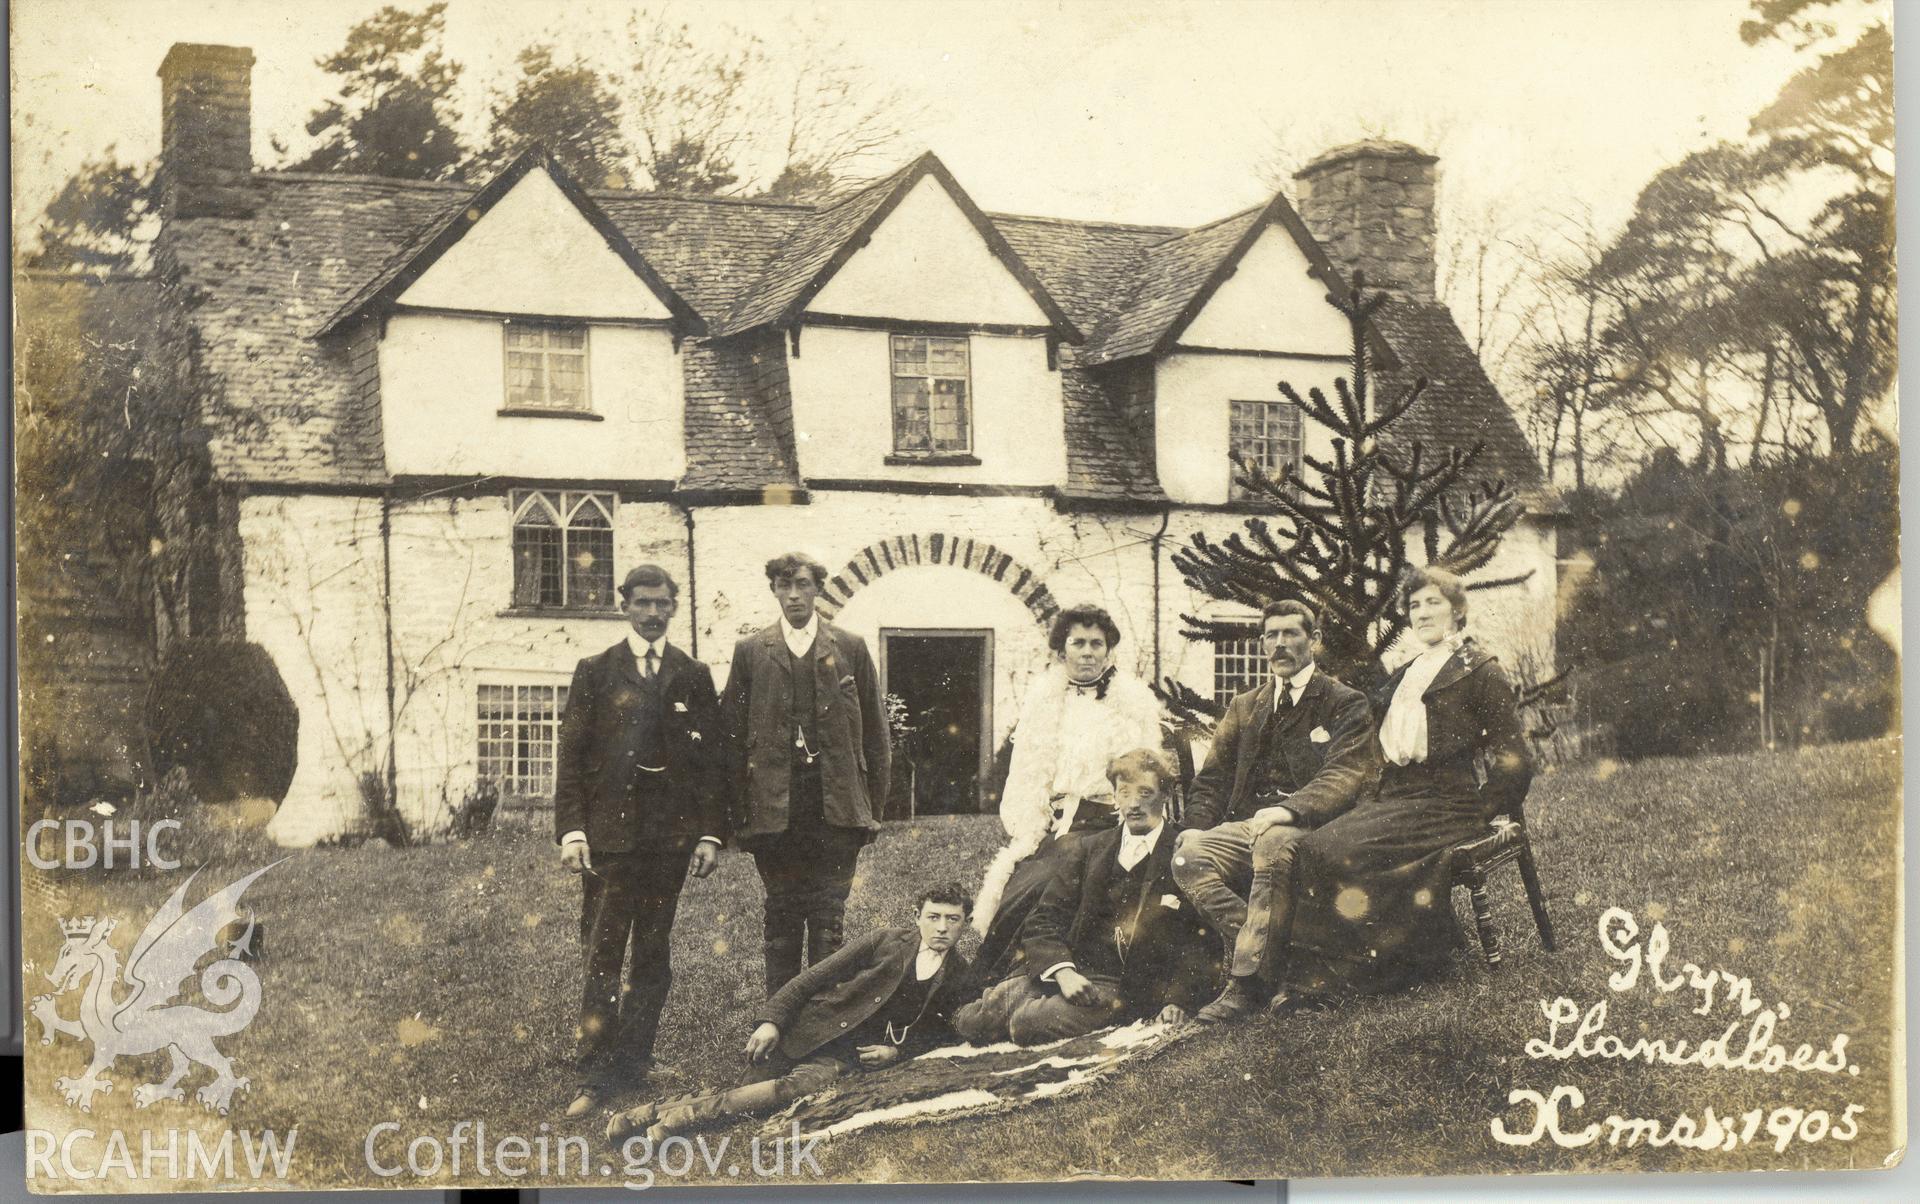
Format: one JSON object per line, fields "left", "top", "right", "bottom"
{"left": 1283, "top": 568, "right": 1532, "bottom": 999}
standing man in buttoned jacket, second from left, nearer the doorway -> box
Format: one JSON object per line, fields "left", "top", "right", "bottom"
{"left": 722, "top": 553, "right": 891, "bottom": 995}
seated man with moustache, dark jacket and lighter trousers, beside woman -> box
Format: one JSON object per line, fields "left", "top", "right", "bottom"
{"left": 1173, "top": 601, "right": 1380, "bottom": 1023}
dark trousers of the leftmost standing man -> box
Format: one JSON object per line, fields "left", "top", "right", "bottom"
{"left": 578, "top": 837, "right": 699, "bottom": 1089}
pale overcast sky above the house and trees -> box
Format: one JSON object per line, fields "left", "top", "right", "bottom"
{"left": 12, "top": 0, "right": 1843, "bottom": 235}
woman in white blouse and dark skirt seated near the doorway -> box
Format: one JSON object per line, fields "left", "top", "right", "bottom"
{"left": 973, "top": 607, "right": 1164, "bottom": 985}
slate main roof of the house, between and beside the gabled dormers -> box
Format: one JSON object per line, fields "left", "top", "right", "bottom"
{"left": 159, "top": 157, "right": 1546, "bottom": 501}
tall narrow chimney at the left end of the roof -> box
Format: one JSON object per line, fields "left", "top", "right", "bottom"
{"left": 159, "top": 42, "right": 253, "bottom": 217}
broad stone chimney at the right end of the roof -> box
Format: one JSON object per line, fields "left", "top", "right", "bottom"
{"left": 1294, "top": 140, "right": 1440, "bottom": 301}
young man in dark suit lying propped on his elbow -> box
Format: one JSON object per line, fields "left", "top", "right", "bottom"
{"left": 607, "top": 881, "right": 973, "bottom": 1148}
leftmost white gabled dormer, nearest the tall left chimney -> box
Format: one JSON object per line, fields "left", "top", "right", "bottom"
{"left": 323, "top": 150, "right": 705, "bottom": 482}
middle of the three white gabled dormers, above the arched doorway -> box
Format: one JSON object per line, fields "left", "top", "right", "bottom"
{"left": 726, "top": 154, "right": 1081, "bottom": 488}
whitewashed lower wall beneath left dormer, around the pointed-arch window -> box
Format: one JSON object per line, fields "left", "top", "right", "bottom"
{"left": 240, "top": 495, "right": 687, "bottom": 845}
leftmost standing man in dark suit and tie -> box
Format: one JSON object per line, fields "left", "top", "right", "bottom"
{"left": 553, "top": 565, "right": 728, "bottom": 1116}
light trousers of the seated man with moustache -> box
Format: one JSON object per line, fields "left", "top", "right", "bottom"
{"left": 1173, "top": 820, "right": 1308, "bottom": 977}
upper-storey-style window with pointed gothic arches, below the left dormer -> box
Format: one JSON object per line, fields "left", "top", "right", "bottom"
{"left": 513, "top": 490, "right": 614, "bottom": 611}
